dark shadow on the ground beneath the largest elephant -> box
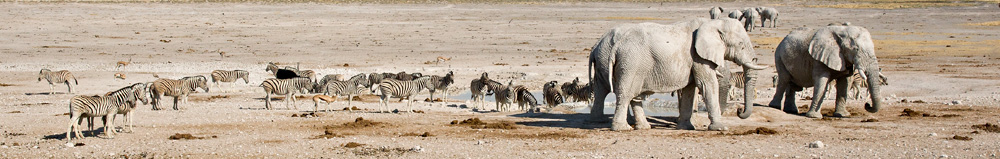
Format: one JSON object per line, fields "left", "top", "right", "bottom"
{"left": 510, "top": 113, "right": 677, "bottom": 130}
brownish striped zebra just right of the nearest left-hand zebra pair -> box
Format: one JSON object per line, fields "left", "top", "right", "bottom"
{"left": 149, "top": 75, "right": 208, "bottom": 110}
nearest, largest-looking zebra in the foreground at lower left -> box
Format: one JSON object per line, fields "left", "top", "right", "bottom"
{"left": 66, "top": 83, "right": 149, "bottom": 140}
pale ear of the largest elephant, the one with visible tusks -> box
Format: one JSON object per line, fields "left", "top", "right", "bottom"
{"left": 694, "top": 21, "right": 726, "bottom": 66}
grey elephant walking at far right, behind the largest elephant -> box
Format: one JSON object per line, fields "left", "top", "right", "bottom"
{"left": 768, "top": 23, "right": 882, "bottom": 118}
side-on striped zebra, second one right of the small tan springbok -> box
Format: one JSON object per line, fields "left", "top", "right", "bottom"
{"left": 378, "top": 77, "right": 431, "bottom": 112}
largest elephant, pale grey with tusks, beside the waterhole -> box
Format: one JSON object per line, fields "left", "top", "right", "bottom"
{"left": 588, "top": 18, "right": 767, "bottom": 131}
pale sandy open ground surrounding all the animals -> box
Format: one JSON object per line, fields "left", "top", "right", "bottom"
{"left": 0, "top": 2, "right": 1000, "bottom": 158}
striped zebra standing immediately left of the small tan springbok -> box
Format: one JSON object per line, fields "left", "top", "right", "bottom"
{"left": 258, "top": 77, "right": 316, "bottom": 110}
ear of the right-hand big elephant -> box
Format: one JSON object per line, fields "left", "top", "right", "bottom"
{"left": 809, "top": 28, "right": 847, "bottom": 71}
